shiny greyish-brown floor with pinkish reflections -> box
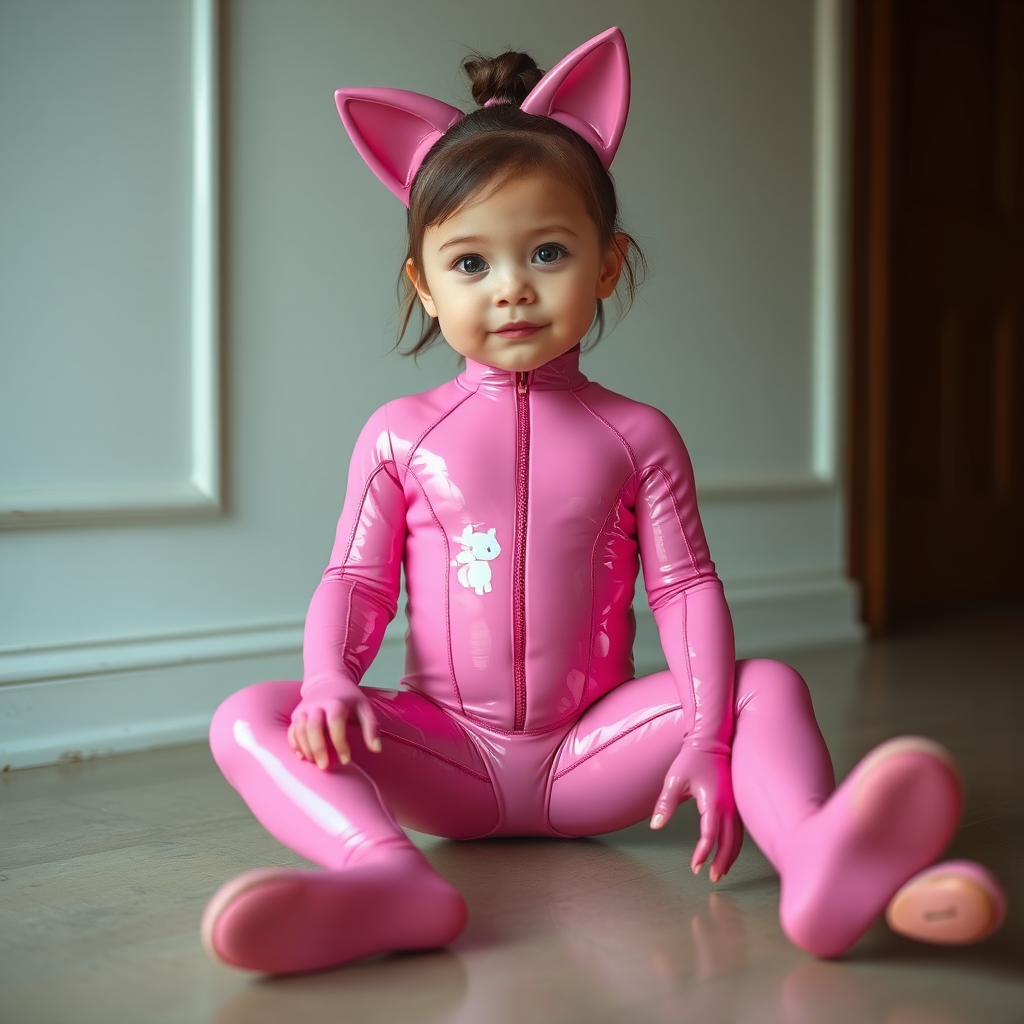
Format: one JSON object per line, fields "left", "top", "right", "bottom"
{"left": 0, "top": 608, "right": 1024, "bottom": 1024}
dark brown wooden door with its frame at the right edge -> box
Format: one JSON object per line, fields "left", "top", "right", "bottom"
{"left": 851, "top": 0, "right": 1024, "bottom": 633}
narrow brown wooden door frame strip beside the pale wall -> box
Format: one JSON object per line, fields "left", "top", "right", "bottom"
{"left": 847, "top": 0, "right": 894, "bottom": 636}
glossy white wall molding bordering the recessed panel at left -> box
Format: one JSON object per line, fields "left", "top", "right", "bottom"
{"left": 0, "top": 0, "right": 221, "bottom": 529}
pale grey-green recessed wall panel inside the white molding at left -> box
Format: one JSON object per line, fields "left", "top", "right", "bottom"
{"left": 0, "top": 0, "right": 209, "bottom": 520}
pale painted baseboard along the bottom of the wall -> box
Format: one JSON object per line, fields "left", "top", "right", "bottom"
{"left": 0, "top": 573, "right": 863, "bottom": 770}
